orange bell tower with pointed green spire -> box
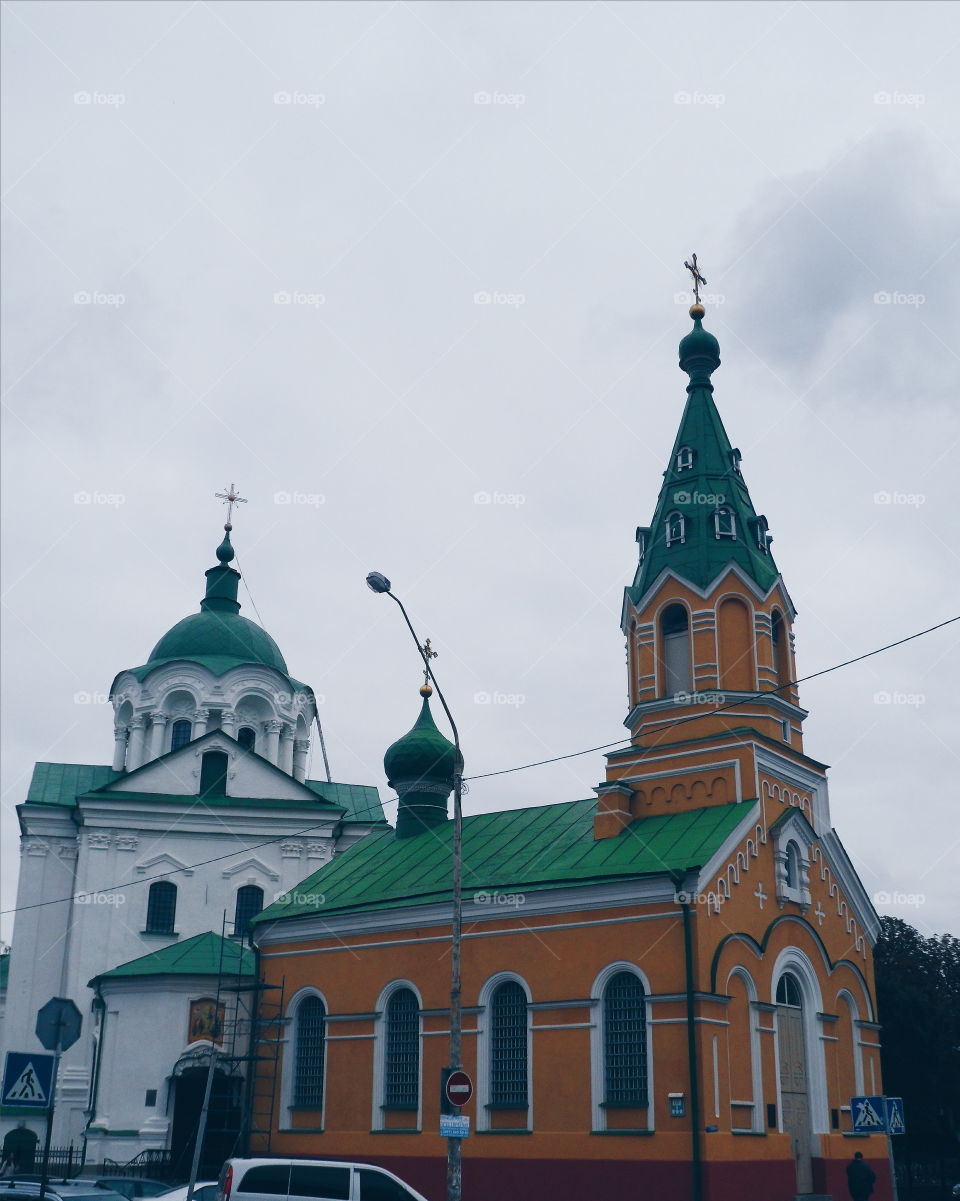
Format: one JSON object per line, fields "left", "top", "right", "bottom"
{"left": 596, "top": 285, "right": 825, "bottom": 837}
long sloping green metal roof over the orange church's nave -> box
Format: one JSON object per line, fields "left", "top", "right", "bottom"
{"left": 255, "top": 799, "right": 753, "bottom": 922}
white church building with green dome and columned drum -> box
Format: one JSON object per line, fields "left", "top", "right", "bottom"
{"left": 0, "top": 522, "right": 384, "bottom": 1176}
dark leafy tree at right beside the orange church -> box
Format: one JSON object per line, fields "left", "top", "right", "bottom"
{"left": 873, "top": 918, "right": 960, "bottom": 1155}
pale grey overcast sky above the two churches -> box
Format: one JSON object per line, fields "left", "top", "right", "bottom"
{"left": 2, "top": 0, "right": 960, "bottom": 938}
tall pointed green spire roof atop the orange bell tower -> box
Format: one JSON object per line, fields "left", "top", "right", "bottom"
{"left": 627, "top": 307, "right": 780, "bottom": 604}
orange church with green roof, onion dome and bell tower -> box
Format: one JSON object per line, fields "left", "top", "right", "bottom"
{"left": 250, "top": 305, "right": 890, "bottom": 1201}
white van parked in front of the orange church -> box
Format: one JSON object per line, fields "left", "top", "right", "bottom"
{"left": 216, "top": 1159, "right": 427, "bottom": 1201}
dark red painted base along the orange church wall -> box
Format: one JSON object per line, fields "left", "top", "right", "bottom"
{"left": 314, "top": 1155, "right": 893, "bottom": 1201}
